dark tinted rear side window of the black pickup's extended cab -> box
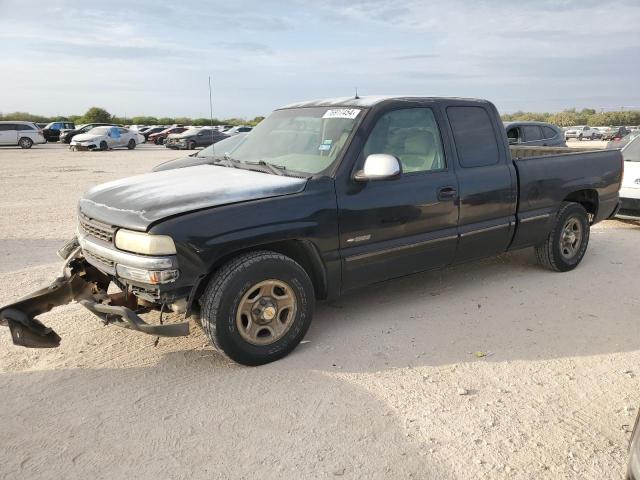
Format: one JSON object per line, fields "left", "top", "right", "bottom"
{"left": 447, "top": 107, "right": 500, "bottom": 168}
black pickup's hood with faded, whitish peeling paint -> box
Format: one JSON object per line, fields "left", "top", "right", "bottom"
{"left": 79, "top": 165, "right": 307, "bottom": 231}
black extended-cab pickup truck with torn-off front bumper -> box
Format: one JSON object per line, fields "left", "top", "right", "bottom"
{"left": 0, "top": 97, "right": 622, "bottom": 365}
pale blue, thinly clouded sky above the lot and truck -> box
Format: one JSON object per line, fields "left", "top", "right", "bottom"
{"left": 0, "top": 0, "right": 640, "bottom": 118}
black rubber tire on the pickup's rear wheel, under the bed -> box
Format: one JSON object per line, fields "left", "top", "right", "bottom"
{"left": 536, "top": 202, "right": 590, "bottom": 272}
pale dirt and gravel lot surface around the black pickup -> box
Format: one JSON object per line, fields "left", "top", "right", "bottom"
{"left": 0, "top": 142, "right": 640, "bottom": 480}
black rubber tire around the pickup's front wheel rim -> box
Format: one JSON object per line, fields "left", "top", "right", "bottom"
{"left": 200, "top": 250, "right": 315, "bottom": 366}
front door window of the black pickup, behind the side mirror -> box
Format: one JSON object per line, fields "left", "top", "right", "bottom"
{"left": 363, "top": 107, "right": 446, "bottom": 173}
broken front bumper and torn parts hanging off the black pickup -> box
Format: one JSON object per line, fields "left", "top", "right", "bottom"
{"left": 0, "top": 239, "right": 189, "bottom": 348}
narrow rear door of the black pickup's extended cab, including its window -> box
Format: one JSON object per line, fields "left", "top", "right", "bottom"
{"left": 445, "top": 101, "right": 517, "bottom": 263}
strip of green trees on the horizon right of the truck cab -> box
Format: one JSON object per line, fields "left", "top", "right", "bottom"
{"left": 502, "top": 108, "right": 640, "bottom": 127}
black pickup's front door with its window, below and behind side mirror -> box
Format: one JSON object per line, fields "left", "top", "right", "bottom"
{"left": 336, "top": 101, "right": 458, "bottom": 290}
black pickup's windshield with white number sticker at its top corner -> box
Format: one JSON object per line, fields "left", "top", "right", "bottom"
{"left": 228, "top": 107, "right": 364, "bottom": 174}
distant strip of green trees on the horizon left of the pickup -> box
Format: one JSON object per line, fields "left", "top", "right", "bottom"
{"left": 0, "top": 107, "right": 264, "bottom": 126}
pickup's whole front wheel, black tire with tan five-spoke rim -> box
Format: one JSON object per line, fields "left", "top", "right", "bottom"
{"left": 200, "top": 251, "right": 314, "bottom": 366}
